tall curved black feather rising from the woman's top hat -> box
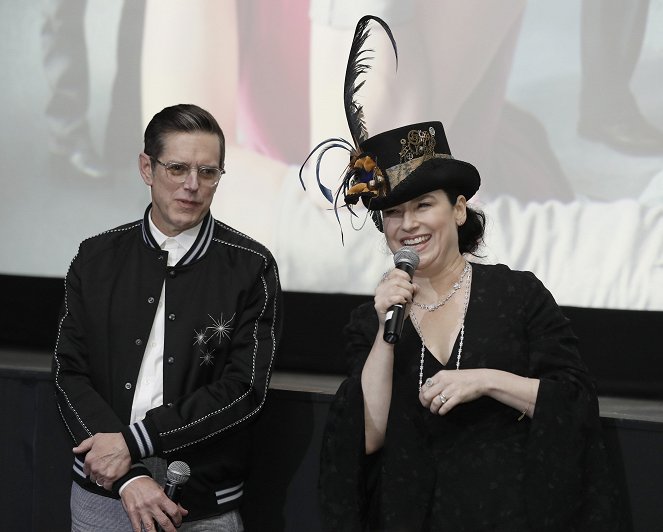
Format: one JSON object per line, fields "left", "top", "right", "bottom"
{"left": 343, "top": 15, "right": 398, "bottom": 147}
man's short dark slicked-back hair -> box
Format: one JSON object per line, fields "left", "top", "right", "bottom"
{"left": 144, "top": 104, "right": 226, "bottom": 168}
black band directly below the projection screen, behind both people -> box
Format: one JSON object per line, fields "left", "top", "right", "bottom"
{"left": 0, "top": 275, "right": 663, "bottom": 399}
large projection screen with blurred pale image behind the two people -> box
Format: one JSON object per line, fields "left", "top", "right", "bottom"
{"left": 0, "top": 0, "right": 663, "bottom": 310}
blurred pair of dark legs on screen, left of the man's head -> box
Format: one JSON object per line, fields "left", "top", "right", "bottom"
{"left": 41, "top": 0, "right": 145, "bottom": 179}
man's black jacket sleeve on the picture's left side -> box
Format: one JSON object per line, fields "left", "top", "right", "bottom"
{"left": 52, "top": 249, "right": 125, "bottom": 444}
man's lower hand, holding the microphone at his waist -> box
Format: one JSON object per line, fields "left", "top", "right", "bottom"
{"left": 121, "top": 477, "right": 189, "bottom": 532}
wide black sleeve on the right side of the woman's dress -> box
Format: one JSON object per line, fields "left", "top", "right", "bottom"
{"left": 523, "top": 274, "right": 619, "bottom": 531}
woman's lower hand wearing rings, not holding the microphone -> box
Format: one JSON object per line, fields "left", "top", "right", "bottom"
{"left": 419, "top": 369, "right": 489, "bottom": 416}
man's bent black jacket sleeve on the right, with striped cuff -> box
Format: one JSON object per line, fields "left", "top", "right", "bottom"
{"left": 122, "top": 250, "right": 282, "bottom": 462}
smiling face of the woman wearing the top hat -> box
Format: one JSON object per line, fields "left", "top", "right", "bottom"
{"left": 382, "top": 190, "right": 467, "bottom": 271}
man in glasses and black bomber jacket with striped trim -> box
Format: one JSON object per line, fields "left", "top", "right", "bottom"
{"left": 53, "top": 105, "right": 281, "bottom": 531}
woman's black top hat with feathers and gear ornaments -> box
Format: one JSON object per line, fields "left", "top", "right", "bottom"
{"left": 299, "top": 15, "right": 481, "bottom": 235}
